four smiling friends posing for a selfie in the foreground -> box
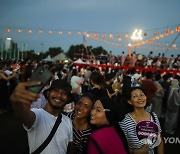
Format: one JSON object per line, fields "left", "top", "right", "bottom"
{"left": 10, "top": 69, "right": 164, "bottom": 154}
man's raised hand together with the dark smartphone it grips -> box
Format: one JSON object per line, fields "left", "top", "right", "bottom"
{"left": 10, "top": 66, "right": 53, "bottom": 105}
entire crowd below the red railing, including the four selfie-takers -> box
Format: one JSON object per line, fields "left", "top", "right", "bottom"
{"left": 0, "top": 56, "right": 180, "bottom": 154}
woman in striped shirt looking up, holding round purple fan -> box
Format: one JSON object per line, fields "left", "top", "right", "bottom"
{"left": 119, "top": 87, "right": 164, "bottom": 154}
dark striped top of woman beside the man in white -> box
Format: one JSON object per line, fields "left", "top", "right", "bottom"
{"left": 67, "top": 112, "right": 92, "bottom": 154}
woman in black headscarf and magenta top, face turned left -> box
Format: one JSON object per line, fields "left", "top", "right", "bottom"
{"left": 88, "top": 97, "right": 129, "bottom": 154}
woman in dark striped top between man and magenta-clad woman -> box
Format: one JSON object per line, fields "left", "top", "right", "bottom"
{"left": 68, "top": 93, "right": 95, "bottom": 154}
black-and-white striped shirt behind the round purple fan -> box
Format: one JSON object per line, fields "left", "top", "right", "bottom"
{"left": 119, "top": 112, "right": 162, "bottom": 154}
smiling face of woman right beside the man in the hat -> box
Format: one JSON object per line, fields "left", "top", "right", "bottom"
{"left": 75, "top": 97, "right": 93, "bottom": 118}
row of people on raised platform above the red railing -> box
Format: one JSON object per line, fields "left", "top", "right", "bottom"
{"left": 81, "top": 51, "right": 180, "bottom": 70}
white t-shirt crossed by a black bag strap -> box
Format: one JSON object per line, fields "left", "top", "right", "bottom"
{"left": 24, "top": 108, "right": 73, "bottom": 154}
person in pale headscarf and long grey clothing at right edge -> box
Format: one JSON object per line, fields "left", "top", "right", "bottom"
{"left": 164, "top": 79, "right": 180, "bottom": 134}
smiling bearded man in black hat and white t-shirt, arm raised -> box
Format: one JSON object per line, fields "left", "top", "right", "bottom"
{"left": 10, "top": 79, "right": 73, "bottom": 154}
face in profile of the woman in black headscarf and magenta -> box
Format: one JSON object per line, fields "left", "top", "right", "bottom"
{"left": 90, "top": 100, "right": 108, "bottom": 126}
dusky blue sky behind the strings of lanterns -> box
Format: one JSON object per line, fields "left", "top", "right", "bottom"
{"left": 0, "top": 0, "right": 180, "bottom": 56}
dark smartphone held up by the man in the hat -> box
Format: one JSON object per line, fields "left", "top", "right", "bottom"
{"left": 27, "top": 66, "right": 53, "bottom": 93}
